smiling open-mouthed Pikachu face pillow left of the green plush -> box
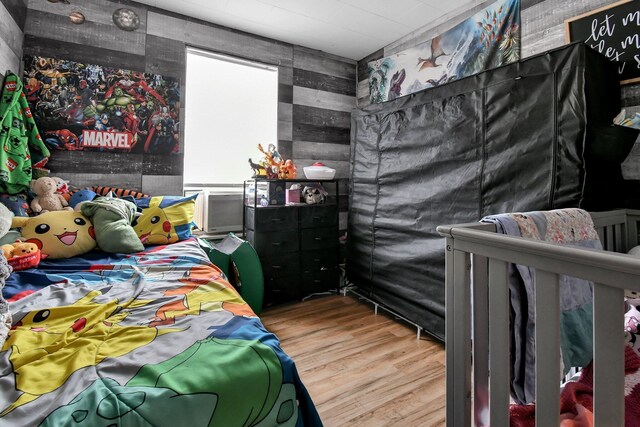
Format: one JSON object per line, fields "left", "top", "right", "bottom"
{"left": 11, "top": 211, "right": 96, "bottom": 259}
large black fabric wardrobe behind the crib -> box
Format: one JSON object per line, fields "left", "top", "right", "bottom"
{"left": 347, "top": 44, "right": 632, "bottom": 340}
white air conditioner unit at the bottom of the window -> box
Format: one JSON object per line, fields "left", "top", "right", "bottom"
{"left": 184, "top": 188, "right": 244, "bottom": 234}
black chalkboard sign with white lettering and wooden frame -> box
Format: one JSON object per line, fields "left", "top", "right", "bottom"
{"left": 565, "top": 0, "right": 640, "bottom": 84}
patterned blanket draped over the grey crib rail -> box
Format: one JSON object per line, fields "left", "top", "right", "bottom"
{"left": 482, "top": 209, "right": 602, "bottom": 404}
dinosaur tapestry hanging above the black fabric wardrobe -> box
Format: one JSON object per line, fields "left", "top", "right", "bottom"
{"left": 368, "top": 0, "right": 520, "bottom": 103}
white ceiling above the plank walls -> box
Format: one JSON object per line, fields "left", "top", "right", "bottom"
{"left": 136, "top": 0, "right": 479, "bottom": 61}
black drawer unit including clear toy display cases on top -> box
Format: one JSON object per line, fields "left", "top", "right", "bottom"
{"left": 244, "top": 179, "right": 339, "bottom": 307}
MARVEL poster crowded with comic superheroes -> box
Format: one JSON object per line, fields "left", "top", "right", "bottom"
{"left": 24, "top": 56, "right": 180, "bottom": 154}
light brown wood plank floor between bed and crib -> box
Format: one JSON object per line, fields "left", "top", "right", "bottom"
{"left": 260, "top": 295, "right": 445, "bottom": 427}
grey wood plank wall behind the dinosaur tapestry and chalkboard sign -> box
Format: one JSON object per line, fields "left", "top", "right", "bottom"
{"left": 357, "top": 0, "right": 640, "bottom": 180}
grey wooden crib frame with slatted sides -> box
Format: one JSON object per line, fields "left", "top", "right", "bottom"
{"left": 438, "top": 210, "right": 640, "bottom": 427}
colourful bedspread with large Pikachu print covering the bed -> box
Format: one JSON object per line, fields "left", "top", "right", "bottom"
{"left": 0, "top": 238, "right": 321, "bottom": 427}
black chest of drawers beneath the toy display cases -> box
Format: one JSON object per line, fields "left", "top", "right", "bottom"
{"left": 244, "top": 181, "right": 339, "bottom": 307}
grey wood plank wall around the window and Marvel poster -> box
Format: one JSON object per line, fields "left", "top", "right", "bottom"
{"left": 21, "top": 0, "right": 356, "bottom": 229}
